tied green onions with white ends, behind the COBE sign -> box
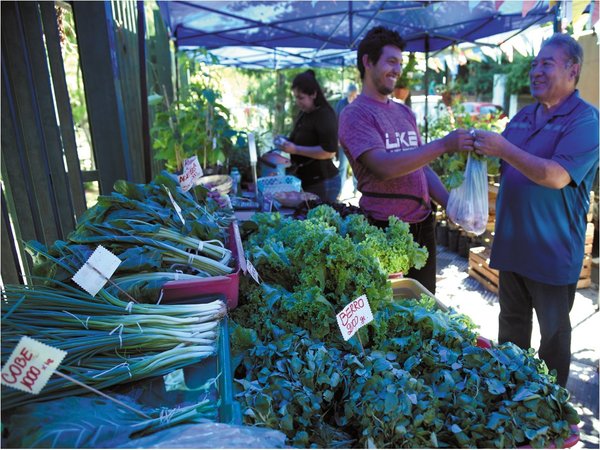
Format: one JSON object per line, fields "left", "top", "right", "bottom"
{"left": 2, "top": 280, "right": 227, "bottom": 409}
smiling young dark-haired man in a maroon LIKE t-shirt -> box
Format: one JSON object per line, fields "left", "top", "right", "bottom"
{"left": 339, "top": 27, "right": 473, "bottom": 293}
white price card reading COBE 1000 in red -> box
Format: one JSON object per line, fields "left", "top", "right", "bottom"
{"left": 1, "top": 336, "right": 67, "bottom": 394}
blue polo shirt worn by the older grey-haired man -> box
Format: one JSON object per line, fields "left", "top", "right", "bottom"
{"left": 490, "top": 91, "right": 599, "bottom": 285}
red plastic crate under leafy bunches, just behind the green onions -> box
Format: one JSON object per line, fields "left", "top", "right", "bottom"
{"left": 161, "top": 222, "right": 246, "bottom": 309}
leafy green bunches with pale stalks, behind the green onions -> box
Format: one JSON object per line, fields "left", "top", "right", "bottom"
{"left": 28, "top": 173, "right": 234, "bottom": 303}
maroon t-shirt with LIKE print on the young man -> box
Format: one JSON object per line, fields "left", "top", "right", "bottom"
{"left": 338, "top": 95, "right": 431, "bottom": 223}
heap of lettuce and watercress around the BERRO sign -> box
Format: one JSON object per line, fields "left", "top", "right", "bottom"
{"left": 231, "top": 206, "right": 579, "bottom": 448}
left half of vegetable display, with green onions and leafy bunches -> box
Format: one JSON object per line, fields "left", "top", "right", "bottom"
{"left": 1, "top": 173, "right": 233, "bottom": 448}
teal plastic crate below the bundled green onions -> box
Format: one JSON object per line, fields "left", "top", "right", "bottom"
{"left": 119, "top": 312, "right": 242, "bottom": 425}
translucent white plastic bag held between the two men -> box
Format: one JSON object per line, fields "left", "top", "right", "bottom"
{"left": 446, "top": 153, "right": 488, "bottom": 235}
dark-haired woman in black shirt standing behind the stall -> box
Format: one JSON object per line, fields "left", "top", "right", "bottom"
{"left": 280, "top": 69, "right": 342, "bottom": 202}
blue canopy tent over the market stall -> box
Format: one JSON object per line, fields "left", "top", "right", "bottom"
{"left": 158, "top": 0, "right": 560, "bottom": 139}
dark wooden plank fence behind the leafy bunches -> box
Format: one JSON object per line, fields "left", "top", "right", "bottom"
{"left": 1, "top": 1, "right": 173, "bottom": 284}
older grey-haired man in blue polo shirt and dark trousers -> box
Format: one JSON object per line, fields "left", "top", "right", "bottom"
{"left": 475, "top": 34, "right": 598, "bottom": 386}
